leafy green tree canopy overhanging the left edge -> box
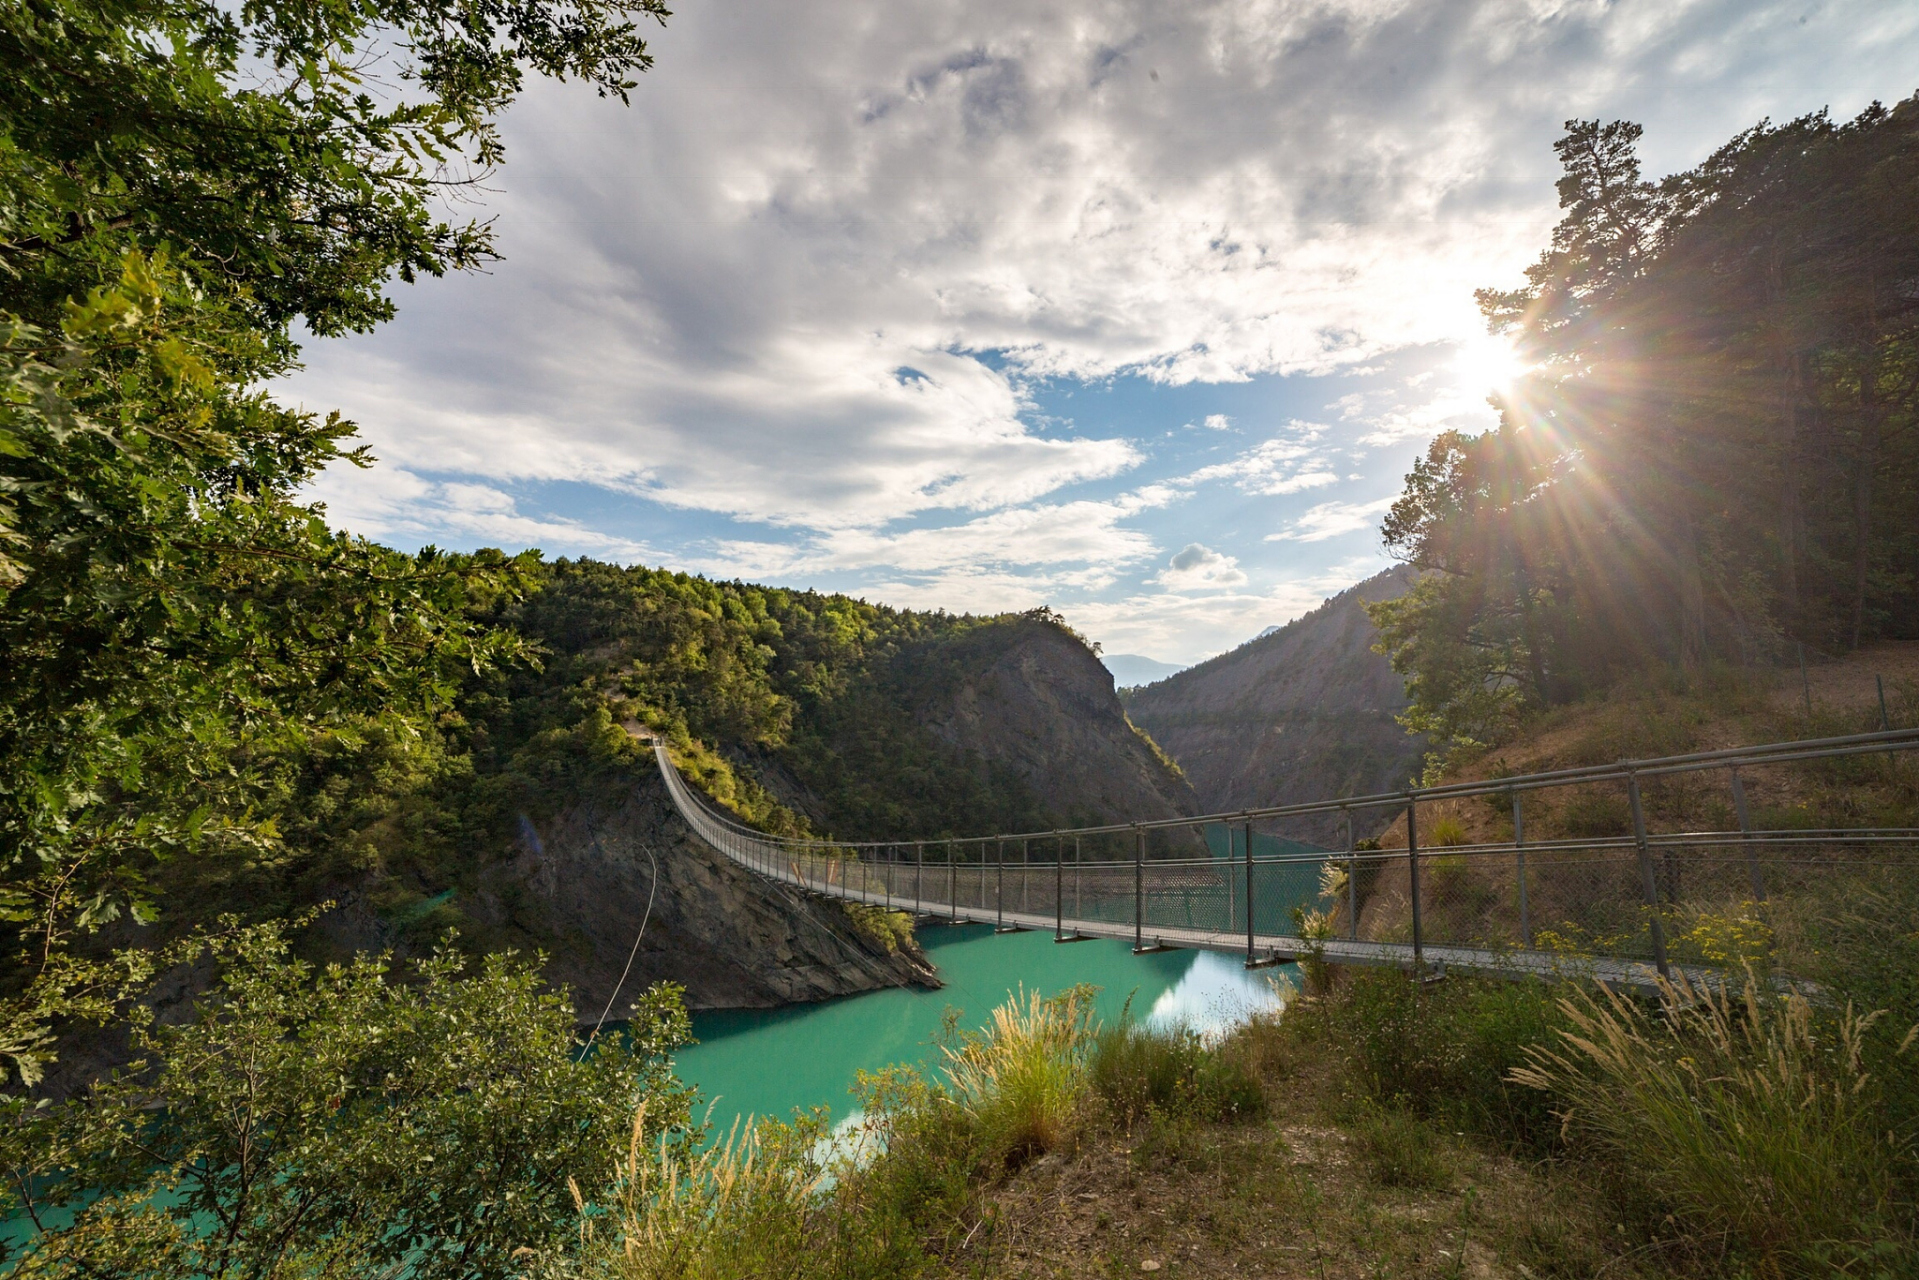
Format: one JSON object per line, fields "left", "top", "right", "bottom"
{"left": 0, "top": 0, "right": 666, "bottom": 1079}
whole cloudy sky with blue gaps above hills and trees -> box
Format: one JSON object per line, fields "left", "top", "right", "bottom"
{"left": 282, "top": 0, "right": 1919, "bottom": 662}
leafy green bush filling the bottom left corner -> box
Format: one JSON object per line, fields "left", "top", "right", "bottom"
{"left": 0, "top": 921, "right": 689, "bottom": 1280}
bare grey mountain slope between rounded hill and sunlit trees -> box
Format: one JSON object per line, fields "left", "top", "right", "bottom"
{"left": 1126, "top": 568, "right": 1426, "bottom": 844}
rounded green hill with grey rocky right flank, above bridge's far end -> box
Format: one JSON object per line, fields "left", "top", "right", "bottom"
{"left": 487, "top": 560, "right": 1196, "bottom": 839}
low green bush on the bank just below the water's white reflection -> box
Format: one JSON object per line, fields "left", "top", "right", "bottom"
{"left": 1088, "top": 1017, "right": 1267, "bottom": 1126}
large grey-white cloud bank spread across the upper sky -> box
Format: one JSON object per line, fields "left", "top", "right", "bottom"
{"left": 294, "top": 0, "right": 1919, "bottom": 530}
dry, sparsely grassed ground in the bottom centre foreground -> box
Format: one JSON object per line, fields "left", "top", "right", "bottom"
{"left": 942, "top": 1057, "right": 1611, "bottom": 1280}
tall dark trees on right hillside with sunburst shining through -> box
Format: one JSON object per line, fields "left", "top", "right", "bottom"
{"left": 1374, "top": 98, "right": 1919, "bottom": 767}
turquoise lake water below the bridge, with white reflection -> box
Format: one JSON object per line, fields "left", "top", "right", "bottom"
{"left": 677, "top": 925, "right": 1291, "bottom": 1132}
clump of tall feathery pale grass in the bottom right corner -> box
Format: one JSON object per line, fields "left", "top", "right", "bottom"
{"left": 1510, "top": 979, "right": 1911, "bottom": 1276}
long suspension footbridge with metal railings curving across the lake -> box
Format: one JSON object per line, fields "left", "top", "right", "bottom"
{"left": 652, "top": 729, "right": 1919, "bottom": 986}
